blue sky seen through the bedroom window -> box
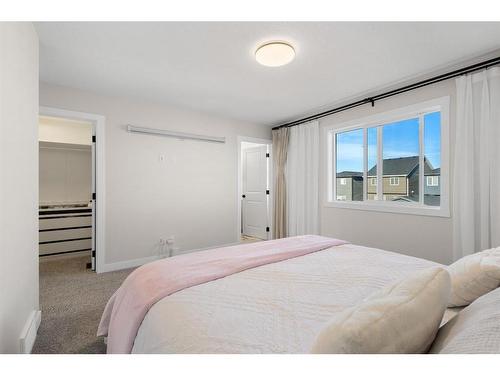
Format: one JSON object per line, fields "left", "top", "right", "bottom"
{"left": 337, "top": 112, "right": 441, "bottom": 172}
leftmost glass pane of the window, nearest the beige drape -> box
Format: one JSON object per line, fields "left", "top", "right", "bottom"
{"left": 335, "top": 129, "right": 363, "bottom": 201}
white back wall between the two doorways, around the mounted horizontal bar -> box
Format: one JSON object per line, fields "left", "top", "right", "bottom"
{"left": 40, "top": 83, "right": 271, "bottom": 269}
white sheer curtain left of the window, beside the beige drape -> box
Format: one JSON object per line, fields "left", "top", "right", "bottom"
{"left": 286, "top": 121, "right": 319, "bottom": 236}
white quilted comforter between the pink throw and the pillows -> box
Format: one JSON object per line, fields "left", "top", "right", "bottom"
{"left": 132, "top": 244, "right": 437, "bottom": 353}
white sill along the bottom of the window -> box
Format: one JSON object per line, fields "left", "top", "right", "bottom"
{"left": 324, "top": 201, "right": 450, "bottom": 217}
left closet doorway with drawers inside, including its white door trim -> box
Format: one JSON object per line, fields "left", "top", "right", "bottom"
{"left": 39, "top": 107, "right": 104, "bottom": 272}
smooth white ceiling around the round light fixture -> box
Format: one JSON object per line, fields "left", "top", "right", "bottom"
{"left": 35, "top": 22, "right": 500, "bottom": 125}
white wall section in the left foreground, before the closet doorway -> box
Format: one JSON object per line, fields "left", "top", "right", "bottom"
{"left": 0, "top": 23, "right": 38, "bottom": 353}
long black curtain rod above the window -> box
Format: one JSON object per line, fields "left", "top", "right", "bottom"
{"left": 273, "top": 56, "right": 500, "bottom": 130}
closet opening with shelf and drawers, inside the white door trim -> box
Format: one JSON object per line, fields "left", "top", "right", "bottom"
{"left": 39, "top": 115, "right": 95, "bottom": 269}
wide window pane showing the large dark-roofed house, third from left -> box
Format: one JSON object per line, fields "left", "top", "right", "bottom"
{"left": 382, "top": 118, "right": 419, "bottom": 202}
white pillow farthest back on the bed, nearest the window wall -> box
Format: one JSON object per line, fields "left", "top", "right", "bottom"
{"left": 448, "top": 247, "right": 500, "bottom": 307}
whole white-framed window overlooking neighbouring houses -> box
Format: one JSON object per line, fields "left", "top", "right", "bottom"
{"left": 327, "top": 98, "right": 449, "bottom": 216}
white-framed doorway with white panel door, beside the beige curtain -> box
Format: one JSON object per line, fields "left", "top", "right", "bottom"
{"left": 238, "top": 137, "right": 272, "bottom": 242}
